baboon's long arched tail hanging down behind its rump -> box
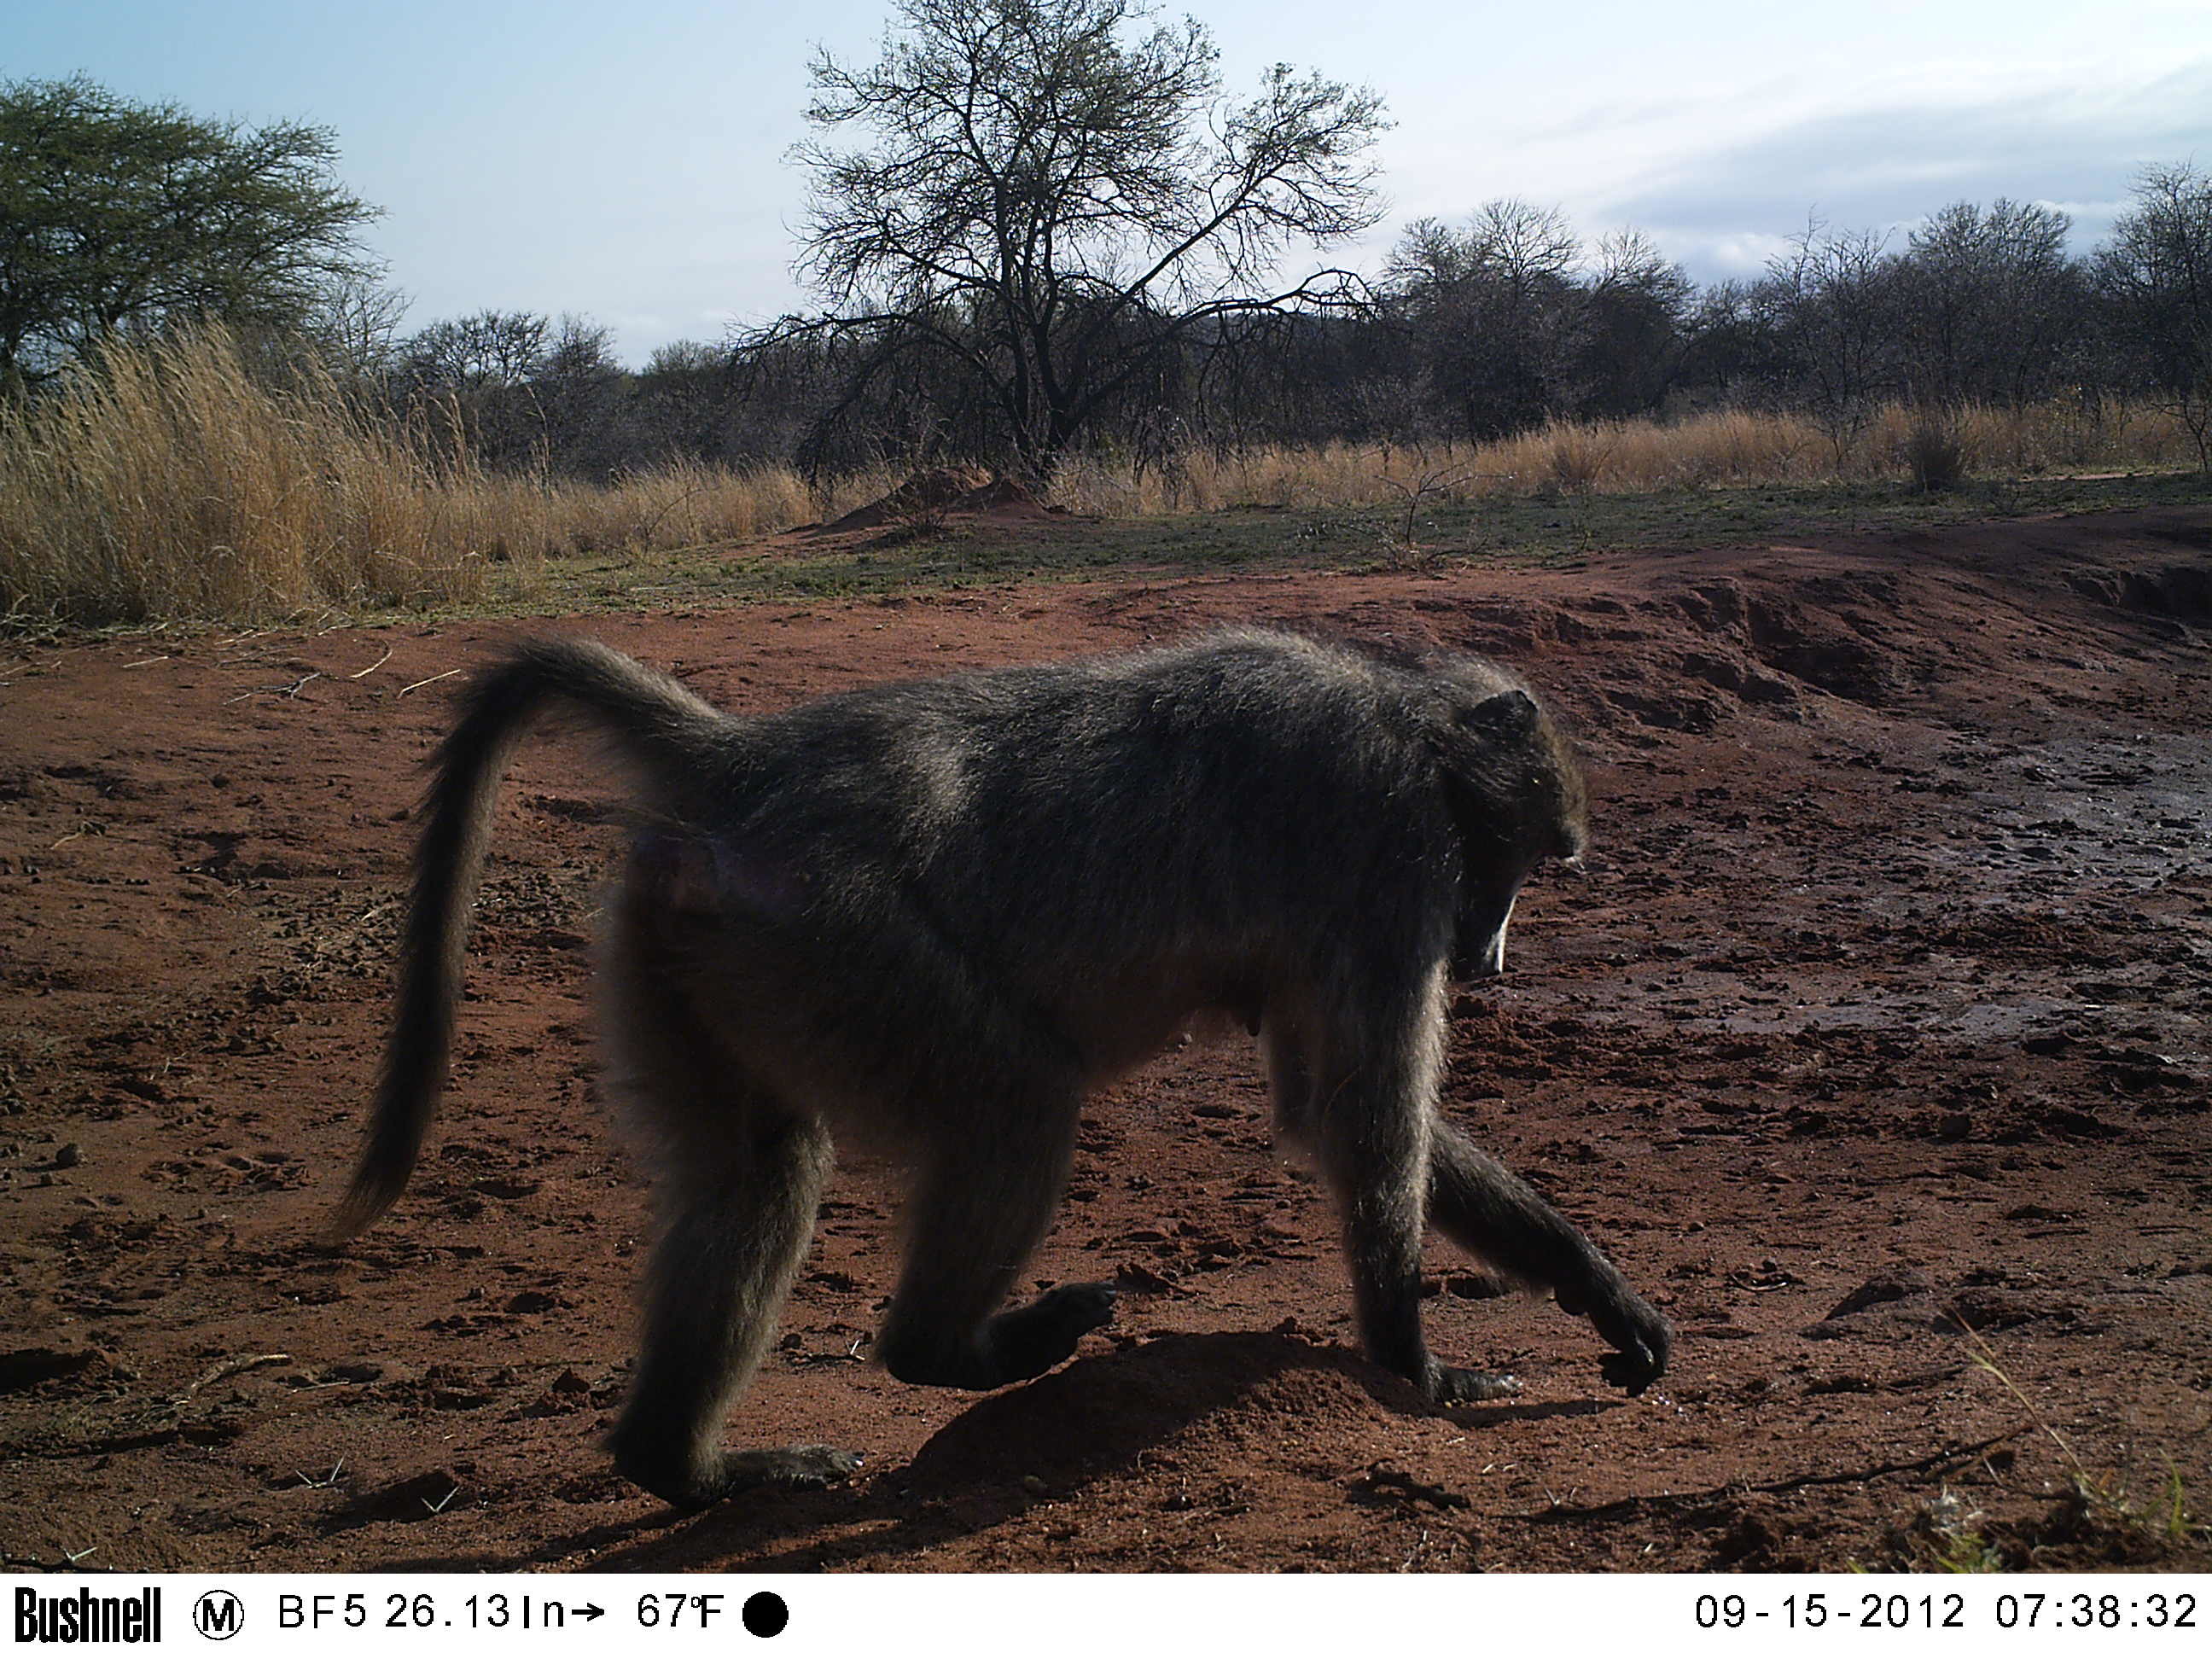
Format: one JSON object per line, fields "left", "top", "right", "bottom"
{"left": 325, "top": 639, "right": 725, "bottom": 1243}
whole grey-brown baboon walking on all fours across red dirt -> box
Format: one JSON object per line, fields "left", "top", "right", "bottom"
{"left": 332, "top": 631, "right": 1670, "bottom": 1506}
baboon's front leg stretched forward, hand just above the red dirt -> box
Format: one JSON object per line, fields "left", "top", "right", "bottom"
{"left": 1429, "top": 1117, "right": 1674, "bottom": 1394}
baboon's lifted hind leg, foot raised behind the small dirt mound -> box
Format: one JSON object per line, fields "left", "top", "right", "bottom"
{"left": 876, "top": 1086, "right": 1115, "bottom": 1389}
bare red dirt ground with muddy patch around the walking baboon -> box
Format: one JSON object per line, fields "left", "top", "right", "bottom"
{"left": 0, "top": 509, "right": 2212, "bottom": 1570}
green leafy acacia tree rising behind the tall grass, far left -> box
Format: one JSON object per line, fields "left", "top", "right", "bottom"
{"left": 0, "top": 75, "right": 376, "bottom": 389}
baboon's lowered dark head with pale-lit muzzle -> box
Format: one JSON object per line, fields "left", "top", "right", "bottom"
{"left": 1434, "top": 686, "right": 1588, "bottom": 980}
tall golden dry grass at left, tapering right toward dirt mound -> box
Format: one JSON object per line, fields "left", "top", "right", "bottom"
{"left": 0, "top": 334, "right": 835, "bottom": 624}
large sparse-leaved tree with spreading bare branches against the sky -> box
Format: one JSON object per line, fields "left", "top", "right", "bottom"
{"left": 750, "top": 0, "right": 1385, "bottom": 475}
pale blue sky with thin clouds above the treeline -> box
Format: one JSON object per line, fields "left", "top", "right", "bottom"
{"left": 0, "top": 0, "right": 2212, "bottom": 363}
